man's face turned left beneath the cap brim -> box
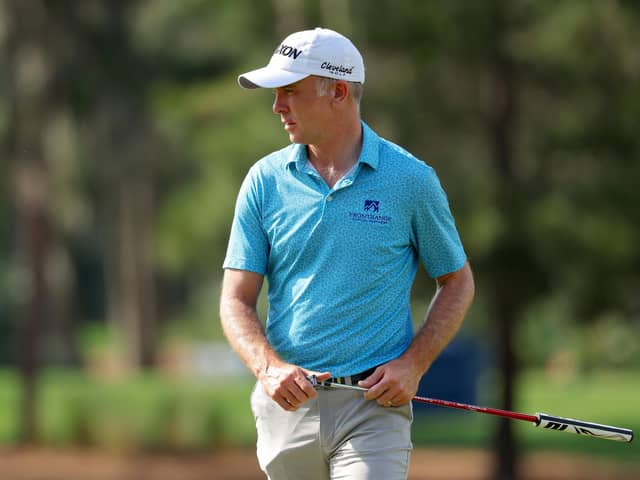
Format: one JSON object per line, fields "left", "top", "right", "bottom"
{"left": 273, "top": 76, "right": 331, "bottom": 145}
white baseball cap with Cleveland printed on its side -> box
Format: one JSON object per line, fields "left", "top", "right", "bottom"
{"left": 238, "top": 28, "right": 364, "bottom": 88}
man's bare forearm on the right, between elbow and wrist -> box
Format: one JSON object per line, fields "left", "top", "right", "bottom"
{"left": 403, "top": 263, "right": 475, "bottom": 376}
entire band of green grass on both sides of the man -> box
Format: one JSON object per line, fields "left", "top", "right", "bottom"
{"left": 0, "top": 370, "right": 640, "bottom": 460}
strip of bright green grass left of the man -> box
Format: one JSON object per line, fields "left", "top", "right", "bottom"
{"left": 0, "top": 370, "right": 255, "bottom": 450}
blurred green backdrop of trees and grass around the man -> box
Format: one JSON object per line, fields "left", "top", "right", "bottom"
{"left": 0, "top": 0, "right": 640, "bottom": 478}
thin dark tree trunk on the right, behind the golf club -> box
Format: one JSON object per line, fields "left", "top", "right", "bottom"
{"left": 489, "top": 2, "right": 525, "bottom": 480}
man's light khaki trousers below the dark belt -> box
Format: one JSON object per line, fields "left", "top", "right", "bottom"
{"left": 251, "top": 383, "right": 413, "bottom": 480}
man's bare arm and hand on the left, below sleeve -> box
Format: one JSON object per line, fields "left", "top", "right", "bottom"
{"left": 220, "top": 269, "right": 331, "bottom": 411}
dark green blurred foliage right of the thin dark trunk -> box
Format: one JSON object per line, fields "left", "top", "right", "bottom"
{"left": 513, "top": 1, "right": 640, "bottom": 338}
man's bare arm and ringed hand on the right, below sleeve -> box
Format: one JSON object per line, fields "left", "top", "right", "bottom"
{"left": 360, "top": 262, "right": 475, "bottom": 406}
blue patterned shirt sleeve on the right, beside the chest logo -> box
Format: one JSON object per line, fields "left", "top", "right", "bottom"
{"left": 413, "top": 168, "right": 467, "bottom": 278}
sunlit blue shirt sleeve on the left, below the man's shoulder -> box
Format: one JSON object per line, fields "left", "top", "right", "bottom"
{"left": 223, "top": 166, "right": 269, "bottom": 275}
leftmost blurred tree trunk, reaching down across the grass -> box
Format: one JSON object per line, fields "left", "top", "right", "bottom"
{"left": 3, "top": 1, "right": 55, "bottom": 442}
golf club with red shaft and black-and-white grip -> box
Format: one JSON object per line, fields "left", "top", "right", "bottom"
{"left": 309, "top": 375, "right": 633, "bottom": 443}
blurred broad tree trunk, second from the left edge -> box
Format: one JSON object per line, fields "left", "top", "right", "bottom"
{"left": 72, "top": 1, "right": 162, "bottom": 369}
